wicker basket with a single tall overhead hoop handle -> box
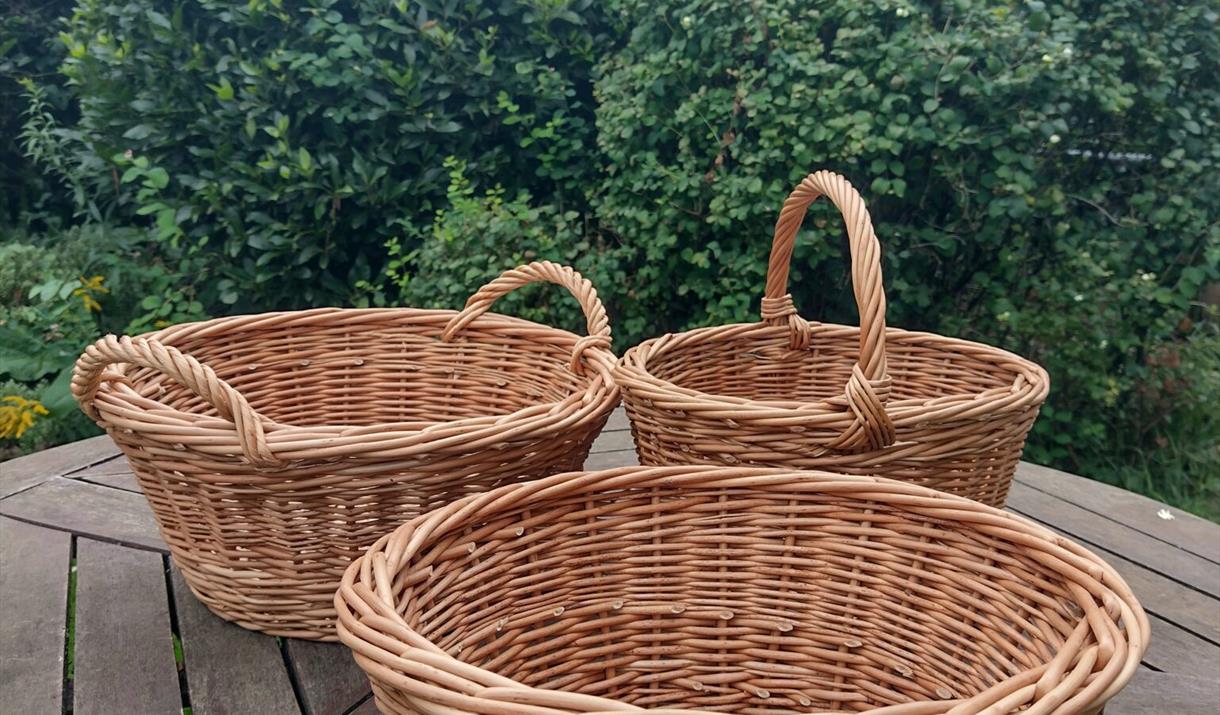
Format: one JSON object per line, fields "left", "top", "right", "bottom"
{"left": 616, "top": 171, "right": 1049, "bottom": 506}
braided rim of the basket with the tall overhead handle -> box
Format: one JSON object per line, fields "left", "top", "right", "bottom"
{"left": 615, "top": 321, "right": 1050, "bottom": 417}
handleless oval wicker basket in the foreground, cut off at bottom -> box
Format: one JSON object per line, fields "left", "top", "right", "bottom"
{"left": 336, "top": 466, "right": 1148, "bottom": 715}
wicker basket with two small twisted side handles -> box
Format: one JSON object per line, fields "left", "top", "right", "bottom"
{"left": 72, "top": 262, "right": 619, "bottom": 641}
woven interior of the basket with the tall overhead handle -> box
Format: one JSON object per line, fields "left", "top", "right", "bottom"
{"left": 648, "top": 326, "right": 1030, "bottom": 403}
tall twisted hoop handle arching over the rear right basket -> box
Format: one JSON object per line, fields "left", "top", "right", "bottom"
{"left": 763, "top": 171, "right": 895, "bottom": 450}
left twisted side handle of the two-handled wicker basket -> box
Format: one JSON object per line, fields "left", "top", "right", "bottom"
{"left": 72, "top": 336, "right": 283, "bottom": 467}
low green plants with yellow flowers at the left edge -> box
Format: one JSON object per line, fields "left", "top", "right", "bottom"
{"left": 0, "top": 225, "right": 203, "bottom": 450}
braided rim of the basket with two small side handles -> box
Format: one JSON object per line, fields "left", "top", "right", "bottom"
{"left": 88, "top": 306, "right": 620, "bottom": 461}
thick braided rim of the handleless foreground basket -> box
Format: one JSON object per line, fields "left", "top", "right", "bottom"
{"left": 334, "top": 465, "right": 1150, "bottom": 715}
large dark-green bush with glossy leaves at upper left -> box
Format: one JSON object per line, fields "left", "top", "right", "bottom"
{"left": 54, "top": 0, "right": 607, "bottom": 309}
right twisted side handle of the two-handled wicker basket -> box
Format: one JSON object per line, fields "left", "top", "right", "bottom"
{"left": 440, "top": 261, "right": 615, "bottom": 375}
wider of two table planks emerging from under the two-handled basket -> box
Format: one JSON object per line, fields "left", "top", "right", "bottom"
{"left": 172, "top": 569, "right": 300, "bottom": 715}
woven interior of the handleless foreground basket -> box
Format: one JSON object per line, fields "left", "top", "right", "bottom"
{"left": 399, "top": 480, "right": 1081, "bottom": 714}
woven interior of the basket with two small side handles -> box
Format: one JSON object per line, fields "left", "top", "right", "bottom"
{"left": 128, "top": 310, "right": 588, "bottom": 426}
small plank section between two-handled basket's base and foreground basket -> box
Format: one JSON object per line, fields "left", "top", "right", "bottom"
{"left": 284, "top": 638, "right": 368, "bottom": 715}
